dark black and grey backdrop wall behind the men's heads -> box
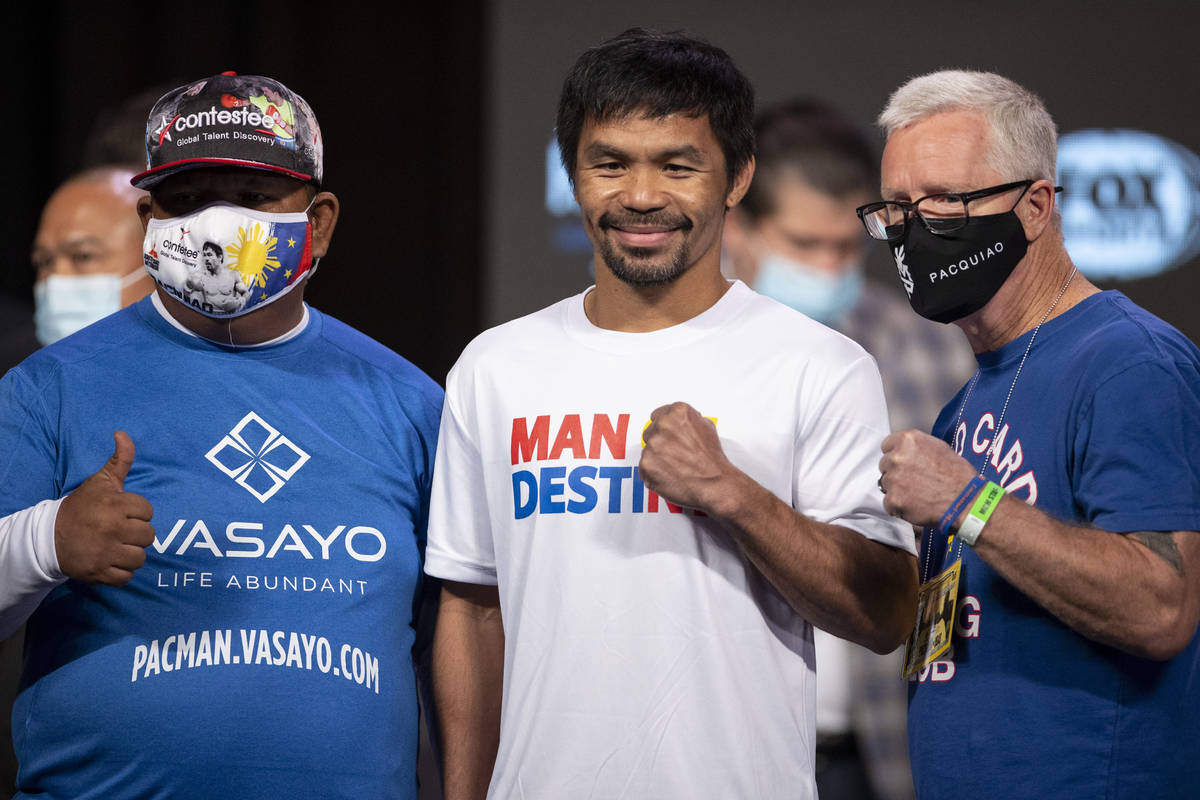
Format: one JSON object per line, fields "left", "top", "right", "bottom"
{"left": 0, "top": 0, "right": 1200, "bottom": 380}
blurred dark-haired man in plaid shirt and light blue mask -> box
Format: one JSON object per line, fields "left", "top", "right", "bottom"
{"left": 724, "top": 100, "right": 974, "bottom": 800}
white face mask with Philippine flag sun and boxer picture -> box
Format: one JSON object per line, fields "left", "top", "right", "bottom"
{"left": 142, "top": 201, "right": 319, "bottom": 319}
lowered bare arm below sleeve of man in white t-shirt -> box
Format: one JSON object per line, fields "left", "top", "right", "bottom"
{"left": 433, "top": 582, "right": 504, "bottom": 800}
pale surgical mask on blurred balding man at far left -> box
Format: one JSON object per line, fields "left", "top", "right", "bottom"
{"left": 34, "top": 270, "right": 145, "bottom": 344}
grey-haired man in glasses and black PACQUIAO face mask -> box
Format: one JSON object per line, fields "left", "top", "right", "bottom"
{"left": 859, "top": 71, "right": 1200, "bottom": 799}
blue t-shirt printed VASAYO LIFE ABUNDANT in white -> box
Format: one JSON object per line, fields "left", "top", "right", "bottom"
{"left": 0, "top": 299, "right": 442, "bottom": 799}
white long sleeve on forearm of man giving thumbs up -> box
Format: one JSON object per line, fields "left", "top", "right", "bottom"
{"left": 0, "top": 500, "right": 66, "bottom": 639}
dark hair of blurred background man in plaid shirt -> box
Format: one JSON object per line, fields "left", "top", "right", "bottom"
{"left": 739, "top": 98, "right": 880, "bottom": 218}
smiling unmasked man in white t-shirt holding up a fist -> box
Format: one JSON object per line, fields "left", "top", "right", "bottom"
{"left": 426, "top": 29, "right": 917, "bottom": 800}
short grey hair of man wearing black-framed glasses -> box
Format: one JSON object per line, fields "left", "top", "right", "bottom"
{"left": 877, "top": 70, "right": 1058, "bottom": 181}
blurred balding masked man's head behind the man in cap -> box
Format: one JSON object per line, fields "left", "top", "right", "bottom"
{"left": 32, "top": 167, "right": 154, "bottom": 344}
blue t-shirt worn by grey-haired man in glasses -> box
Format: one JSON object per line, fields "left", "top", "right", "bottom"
{"left": 908, "top": 291, "right": 1200, "bottom": 800}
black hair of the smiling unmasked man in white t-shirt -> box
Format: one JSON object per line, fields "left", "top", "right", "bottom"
{"left": 554, "top": 28, "right": 754, "bottom": 184}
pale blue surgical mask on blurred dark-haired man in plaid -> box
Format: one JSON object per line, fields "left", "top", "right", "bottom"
{"left": 754, "top": 251, "right": 863, "bottom": 325}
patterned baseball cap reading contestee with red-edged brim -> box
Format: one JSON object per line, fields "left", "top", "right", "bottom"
{"left": 130, "top": 72, "right": 324, "bottom": 190}
